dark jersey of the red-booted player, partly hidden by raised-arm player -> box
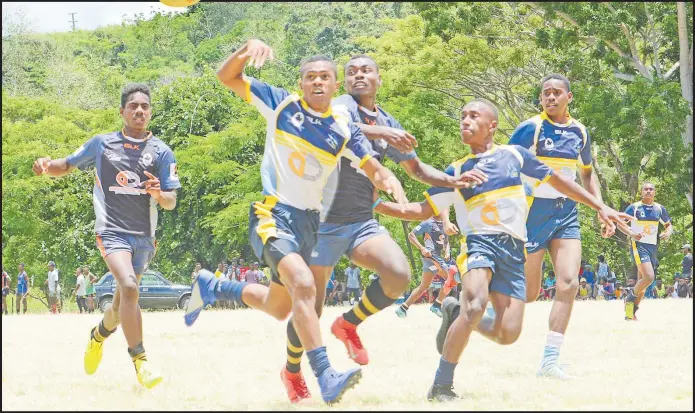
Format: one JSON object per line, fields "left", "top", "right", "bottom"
{"left": 321, "top": 95, "right": 417, "bottom": 224}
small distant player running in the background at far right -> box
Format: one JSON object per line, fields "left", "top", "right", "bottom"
{"left": 625, "top": 182, "right": 673, "bottom": 321}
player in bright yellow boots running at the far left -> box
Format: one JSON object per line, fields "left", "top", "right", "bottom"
{"left": 34, "top": 84, "right": 181, "bottom": 388}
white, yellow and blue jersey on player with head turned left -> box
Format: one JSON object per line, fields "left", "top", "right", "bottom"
{"left": 425, "top": 145, "right": 553, "bottom": 242}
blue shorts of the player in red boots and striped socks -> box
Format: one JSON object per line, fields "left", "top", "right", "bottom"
{"left": 311, "top": 219, "right": 389, "bottom": 267}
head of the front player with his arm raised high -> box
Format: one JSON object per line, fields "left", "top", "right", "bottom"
{"left": 299, "top": 55, "right": 339, "bottom": 112}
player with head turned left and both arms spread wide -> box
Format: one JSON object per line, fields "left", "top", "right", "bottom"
{"left": 376, "top": 99, "right": 627, "bottom": 400}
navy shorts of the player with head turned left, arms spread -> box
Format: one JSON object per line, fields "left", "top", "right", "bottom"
{"left": 456, "top": 234, "right": 526, "bottom": 300}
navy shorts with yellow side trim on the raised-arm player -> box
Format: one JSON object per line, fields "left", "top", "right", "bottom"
{"left": 249, "top": 196, "right": 320, "bottom": 285}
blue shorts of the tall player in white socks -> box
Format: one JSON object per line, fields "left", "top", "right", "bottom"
{"left": 526, "top": 198, "right": 582, "bottom": 253}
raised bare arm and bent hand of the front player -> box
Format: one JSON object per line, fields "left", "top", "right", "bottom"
{"left": 217, "top": 39, "right": 274, "bottom": 99}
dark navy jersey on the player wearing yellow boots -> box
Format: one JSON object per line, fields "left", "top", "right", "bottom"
{"left": 66, "top": 131, "right": 181, "bottom": 237}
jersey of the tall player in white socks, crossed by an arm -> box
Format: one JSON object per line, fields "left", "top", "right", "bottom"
{"left": 509, "top": 111, "right": 592, "bottom": 199}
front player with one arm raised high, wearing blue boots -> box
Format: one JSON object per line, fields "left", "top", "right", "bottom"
{"left": 185, "top": 39, "right": 406, "bottom": 403}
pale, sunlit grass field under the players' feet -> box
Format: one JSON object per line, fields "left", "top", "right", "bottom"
{"left": 2, "top": 299, "right": 693, "bottom": 410}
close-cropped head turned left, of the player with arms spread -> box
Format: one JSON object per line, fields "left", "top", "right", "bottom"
{"left": 459, "top": 98, "right": 499, "bottom": 145}
